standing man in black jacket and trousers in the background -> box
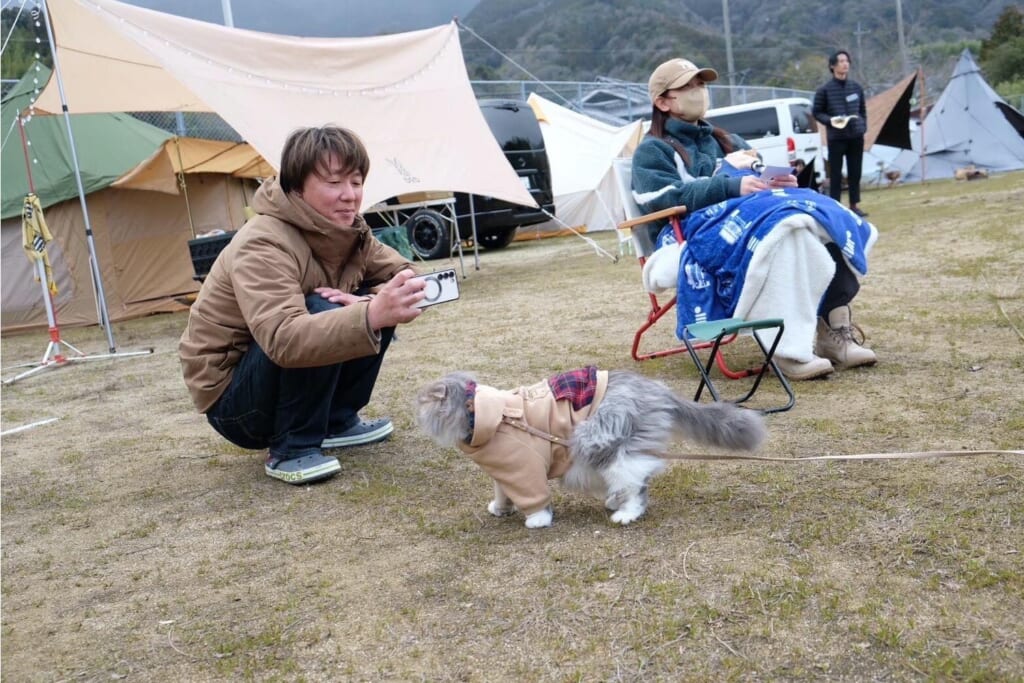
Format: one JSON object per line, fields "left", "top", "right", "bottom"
{"left": 813, "top": 50, "right": 867, "bottom": 217}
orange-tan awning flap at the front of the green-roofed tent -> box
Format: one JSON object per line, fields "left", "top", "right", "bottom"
{"left": 114, "top": 137, "right": 275, "bottom": 195}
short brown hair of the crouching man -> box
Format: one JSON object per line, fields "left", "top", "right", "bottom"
{"left": 278, "top": 125, "right": 370, "bottom": 193}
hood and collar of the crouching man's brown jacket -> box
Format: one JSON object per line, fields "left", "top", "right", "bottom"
{"left": 252, "top": 178, "right": 371, "bottom": 269}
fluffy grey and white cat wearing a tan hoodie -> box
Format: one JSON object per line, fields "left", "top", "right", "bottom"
{"left": 415, "top": 367, "right": 765, "bottom": 528}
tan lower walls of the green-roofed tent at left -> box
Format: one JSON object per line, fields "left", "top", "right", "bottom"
{"left": 0, "top": 173, "right": 255, "bottom": 334}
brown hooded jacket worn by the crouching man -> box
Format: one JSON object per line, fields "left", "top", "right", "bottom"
{"left": 178, "top": 179, "right": 411, "bottom": 413}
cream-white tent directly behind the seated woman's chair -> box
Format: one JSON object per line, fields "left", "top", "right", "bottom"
{"left": 520, "top": 92, "right": 641, "bottom": 237}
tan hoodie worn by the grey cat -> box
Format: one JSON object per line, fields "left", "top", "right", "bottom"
{"left": 459, "top": 371, "right": 608, "bottom": 515}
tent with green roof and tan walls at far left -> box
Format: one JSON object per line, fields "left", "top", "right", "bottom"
{"left": 0, "top": 65, "right": 260, "bottom": 334}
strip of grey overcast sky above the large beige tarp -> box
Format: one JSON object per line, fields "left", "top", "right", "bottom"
{"left": 118, "top": 0, "right": 479, "bottom": 38}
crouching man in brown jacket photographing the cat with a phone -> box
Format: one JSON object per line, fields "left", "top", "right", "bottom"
{"left": 178, "top": 126, "right": 424, "bottom": 484}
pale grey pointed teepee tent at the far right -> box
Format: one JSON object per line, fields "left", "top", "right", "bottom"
{"left": 892, "top": 49, "right": 1024, "bottom": 181}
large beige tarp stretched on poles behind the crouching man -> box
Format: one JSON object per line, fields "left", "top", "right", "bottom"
{"left": 36, "top": 0, "right": 536, "bottom": 206}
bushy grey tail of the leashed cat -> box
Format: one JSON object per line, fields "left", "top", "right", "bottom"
{"left": 673, "top": 395, "right": 766, "bottom": 451}
